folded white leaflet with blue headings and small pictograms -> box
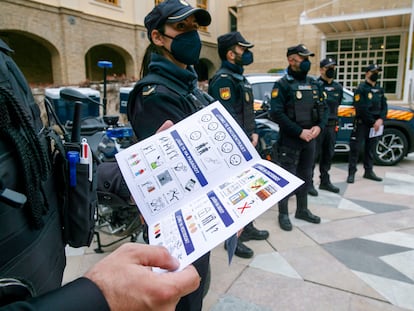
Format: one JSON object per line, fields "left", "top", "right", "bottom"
{"left": 116, "top": 102, "right": 303, "bottom": 270}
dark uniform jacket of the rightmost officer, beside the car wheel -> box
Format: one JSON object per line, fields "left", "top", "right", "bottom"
{"left": 354, "top": 81, "right": 388, "bottom": 127}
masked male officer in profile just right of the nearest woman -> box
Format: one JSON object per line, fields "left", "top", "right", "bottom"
{"left": 208, "top": 31, "right": 269, "bottom": 258}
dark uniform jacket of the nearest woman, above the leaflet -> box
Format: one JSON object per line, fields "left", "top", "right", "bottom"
{"left": 128, "top": 54, "right": 211, "bottom": 140}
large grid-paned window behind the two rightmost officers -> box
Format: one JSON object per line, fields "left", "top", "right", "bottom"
{"left": 326, "top": 35, "right": 403, "bottom": 97}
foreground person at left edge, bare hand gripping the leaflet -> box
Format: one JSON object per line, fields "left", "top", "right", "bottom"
{"left": 0, "top": 39, "right": 200, "bottom": 311}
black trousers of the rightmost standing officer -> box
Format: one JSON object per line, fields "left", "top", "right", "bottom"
{"left": 348, "top": 123, "right": 378, "bottom": 174}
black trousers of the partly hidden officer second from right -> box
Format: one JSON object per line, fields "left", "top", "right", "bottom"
{"left": 312, "top": 126, "right": 336, "bottom": 184}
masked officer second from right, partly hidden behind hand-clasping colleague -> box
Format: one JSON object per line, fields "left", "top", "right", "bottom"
{"left": 309, "top": 58, "right": 343, "bottom": 194}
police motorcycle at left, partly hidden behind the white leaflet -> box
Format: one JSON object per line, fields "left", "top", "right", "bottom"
{"left": 51, "top": 88, "right": 144, "bottom": 253}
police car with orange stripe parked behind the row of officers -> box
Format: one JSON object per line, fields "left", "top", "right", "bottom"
{"left": 246, "top": 74, "right": 414, "bottom": 166}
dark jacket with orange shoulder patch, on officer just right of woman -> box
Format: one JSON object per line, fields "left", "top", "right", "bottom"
{"left": 208, "top": 61, "right": 256, "bottom": 137}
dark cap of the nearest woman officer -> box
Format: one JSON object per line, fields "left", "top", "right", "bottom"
{"left": 144, "top": 0, "right": 211, "bottom": 38}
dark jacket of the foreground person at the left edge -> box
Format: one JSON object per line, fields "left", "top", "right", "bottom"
{"left": 0, "top": 39, "right": 109, "bottom": 310}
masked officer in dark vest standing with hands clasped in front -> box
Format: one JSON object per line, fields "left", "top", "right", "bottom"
{"left": 270, "top": 44, "right": 328, "bottom": 231}
